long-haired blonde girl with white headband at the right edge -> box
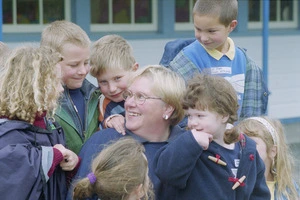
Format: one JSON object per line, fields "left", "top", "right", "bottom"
{"left": 225, "top": 116, "right": 300, "bottom": 200}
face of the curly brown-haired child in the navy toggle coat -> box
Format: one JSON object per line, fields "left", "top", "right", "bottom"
{"left": 186, "top": 108, "right": 227, "bottom": 139}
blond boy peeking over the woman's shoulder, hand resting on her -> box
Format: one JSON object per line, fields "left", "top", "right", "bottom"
{"left": 91, "top": 35, "right": 138, "bottom": 133}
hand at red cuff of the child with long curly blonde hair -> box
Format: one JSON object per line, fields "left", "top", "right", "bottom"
{"left": 54, "top": 144, "right": 79, "bottom": 171}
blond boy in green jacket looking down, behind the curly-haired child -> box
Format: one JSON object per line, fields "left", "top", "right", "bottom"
{"left": 41, "top": 21, "right": 100, "bottom": 153}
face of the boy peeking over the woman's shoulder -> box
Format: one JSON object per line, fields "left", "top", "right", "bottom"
{"left": 97, "top": 69, "right": 132, "bottom": 102}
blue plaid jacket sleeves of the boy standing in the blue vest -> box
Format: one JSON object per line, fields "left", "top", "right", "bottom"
{"left": 160, "top": 39, "right": 269, "bottom": 120}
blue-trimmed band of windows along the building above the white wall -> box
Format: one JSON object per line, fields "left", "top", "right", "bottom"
{"left": 2, "top": 0, "right": 300, "bottom": 42}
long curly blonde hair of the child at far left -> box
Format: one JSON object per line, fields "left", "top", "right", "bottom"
{"left": 0, "top": 46, "right": 61, "bottom": 123}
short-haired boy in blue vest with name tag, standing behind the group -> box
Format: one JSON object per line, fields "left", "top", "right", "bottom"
{"left": 162, "top": 0, "right": 269, "bottom": 119}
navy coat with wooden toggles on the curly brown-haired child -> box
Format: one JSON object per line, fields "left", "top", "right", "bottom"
{"left": 154, "top": 131, "right": 270, "bottom": 200}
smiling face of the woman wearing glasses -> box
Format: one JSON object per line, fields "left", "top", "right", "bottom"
{"left": 125, "top": 77, "right": 166, "bottom": 135}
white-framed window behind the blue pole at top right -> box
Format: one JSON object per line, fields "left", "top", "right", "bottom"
{"left": 248, "top": 0, "right": 298, "bottom": 29}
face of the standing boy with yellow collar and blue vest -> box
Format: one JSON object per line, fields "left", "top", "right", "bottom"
{"left": 194, "top": 15, "right": 234, "bottom": 53}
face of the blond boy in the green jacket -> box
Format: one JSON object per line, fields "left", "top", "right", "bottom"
{"left": 60, "top": 44, "right": 90, "bottom": 89}
